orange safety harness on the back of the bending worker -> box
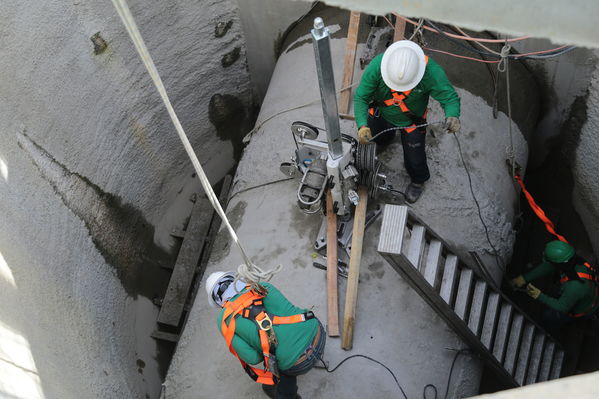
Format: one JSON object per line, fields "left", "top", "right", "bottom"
{"left": 221, "top": 286, "right": 314, "bottom": 385}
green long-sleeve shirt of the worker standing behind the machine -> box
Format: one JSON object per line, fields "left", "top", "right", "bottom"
{"left": 354, "top": 54, "right": 460, "bottom": 127}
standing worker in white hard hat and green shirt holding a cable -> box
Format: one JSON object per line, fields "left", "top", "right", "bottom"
{"left": 354, "top": 40, "right": 460, "bottom": 203}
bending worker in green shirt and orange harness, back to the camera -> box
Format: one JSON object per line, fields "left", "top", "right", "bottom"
{"left": 206, "top": 272, "right": 326, "bottom": 399}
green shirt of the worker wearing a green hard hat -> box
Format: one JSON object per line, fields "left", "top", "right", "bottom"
{"left": 524, "top": 262, "right": 599, "bottom": 314}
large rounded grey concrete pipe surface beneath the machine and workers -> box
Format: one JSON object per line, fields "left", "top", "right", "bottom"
{"left": 165, "top": 26, "right": 527, "bottom": 399}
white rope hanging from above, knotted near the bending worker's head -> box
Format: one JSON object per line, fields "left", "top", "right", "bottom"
{"left": 112, "top": 0, "right": 282, "bottom": 287}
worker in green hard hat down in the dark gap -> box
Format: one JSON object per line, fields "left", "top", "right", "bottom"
{"left": 510, "top": 240, "right": 599, "bottom": 327}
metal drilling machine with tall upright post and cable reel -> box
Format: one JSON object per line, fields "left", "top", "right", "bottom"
{"left": 280, "top": 18, "right": 397, "bottom": 251}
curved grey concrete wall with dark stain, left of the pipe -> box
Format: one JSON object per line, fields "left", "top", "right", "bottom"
{"left": 0, "top": 0, "right": 251, "bottom": 399}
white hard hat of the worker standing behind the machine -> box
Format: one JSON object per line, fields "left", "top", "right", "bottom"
{"left": 381, "top": 40, "right": 426, "bottom": 91}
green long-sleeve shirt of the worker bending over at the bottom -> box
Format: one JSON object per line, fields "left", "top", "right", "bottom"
{"left": 217, "top": 283, "right": 319, "bottom": 370}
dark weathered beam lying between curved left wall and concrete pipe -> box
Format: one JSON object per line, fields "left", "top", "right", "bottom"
{"left": 158, "top": 195, "right": 212, "bottom": 327}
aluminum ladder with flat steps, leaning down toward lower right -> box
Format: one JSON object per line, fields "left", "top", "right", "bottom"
{"left": 378, "top": 204, "right": 564, "bottom": 386}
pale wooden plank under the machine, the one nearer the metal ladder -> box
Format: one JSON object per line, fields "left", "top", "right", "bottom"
{"left": 341, "top": 186, "right": 368, "bottom": 350}
